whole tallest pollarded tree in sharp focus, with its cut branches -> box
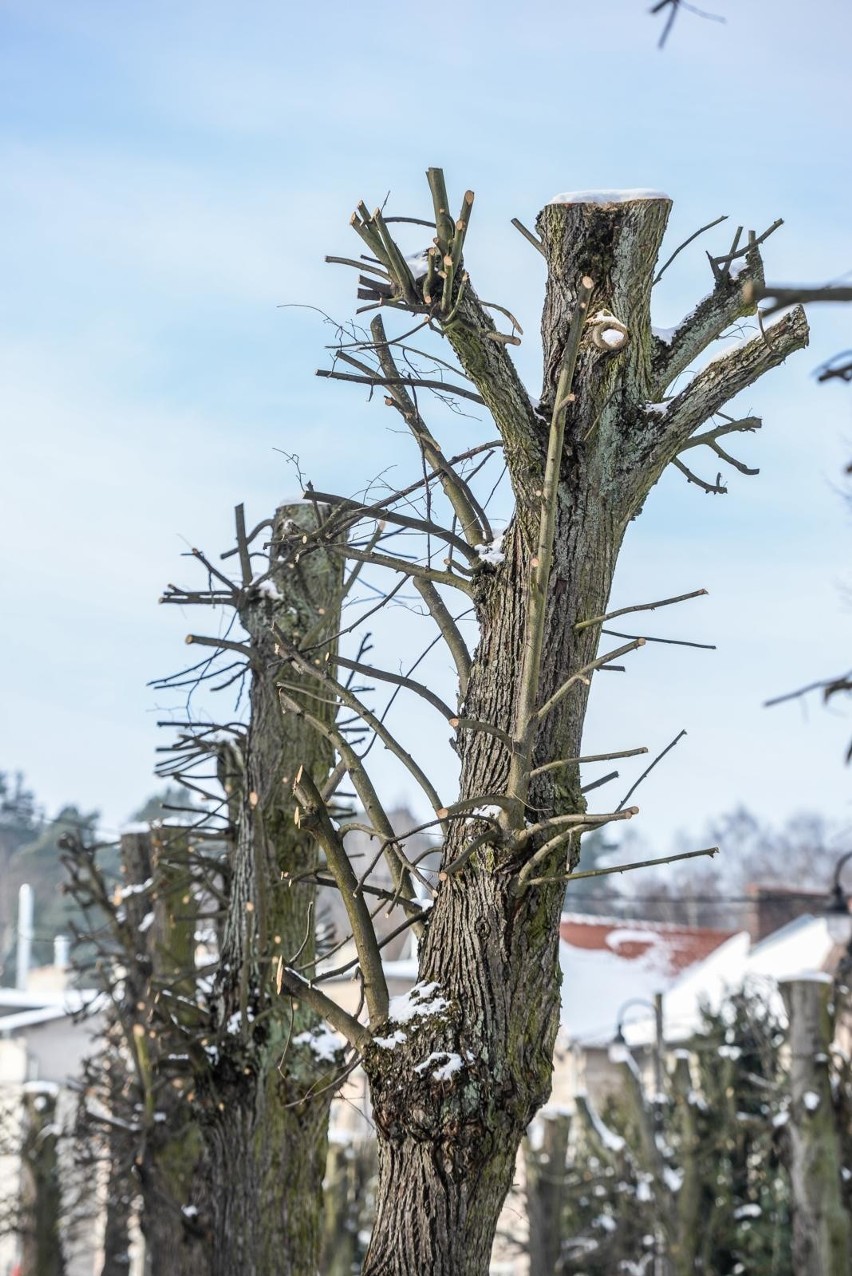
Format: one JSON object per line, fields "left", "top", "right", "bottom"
{"left": 271, "top": 170, "right": 807, "bottom": 1276}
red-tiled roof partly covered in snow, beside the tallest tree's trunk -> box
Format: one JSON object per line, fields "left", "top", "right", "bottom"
{"left": 559, "top": 914, "right": 731, "bottom": 1045}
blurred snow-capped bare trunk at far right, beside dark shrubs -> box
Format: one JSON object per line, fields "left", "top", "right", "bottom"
{"left": 781, "top": 975, "right": 852, "bottom": 1276}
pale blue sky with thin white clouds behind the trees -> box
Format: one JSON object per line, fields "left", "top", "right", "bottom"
{"left": 0, "top": 0, "right": 852, "bottom": 843}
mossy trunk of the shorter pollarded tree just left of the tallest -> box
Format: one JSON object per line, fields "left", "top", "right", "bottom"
{"left": 199, "top": 504, "right": 341, "bottom": 1276}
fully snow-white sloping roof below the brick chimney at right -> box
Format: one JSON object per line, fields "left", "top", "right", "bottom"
{"left": 625, "top": 914, "right": 835, "bottom": 1045}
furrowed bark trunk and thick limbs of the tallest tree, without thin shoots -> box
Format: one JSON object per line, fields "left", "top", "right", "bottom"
{"left": 352, "top": 185, "right": 807, "bottom": 1276}
